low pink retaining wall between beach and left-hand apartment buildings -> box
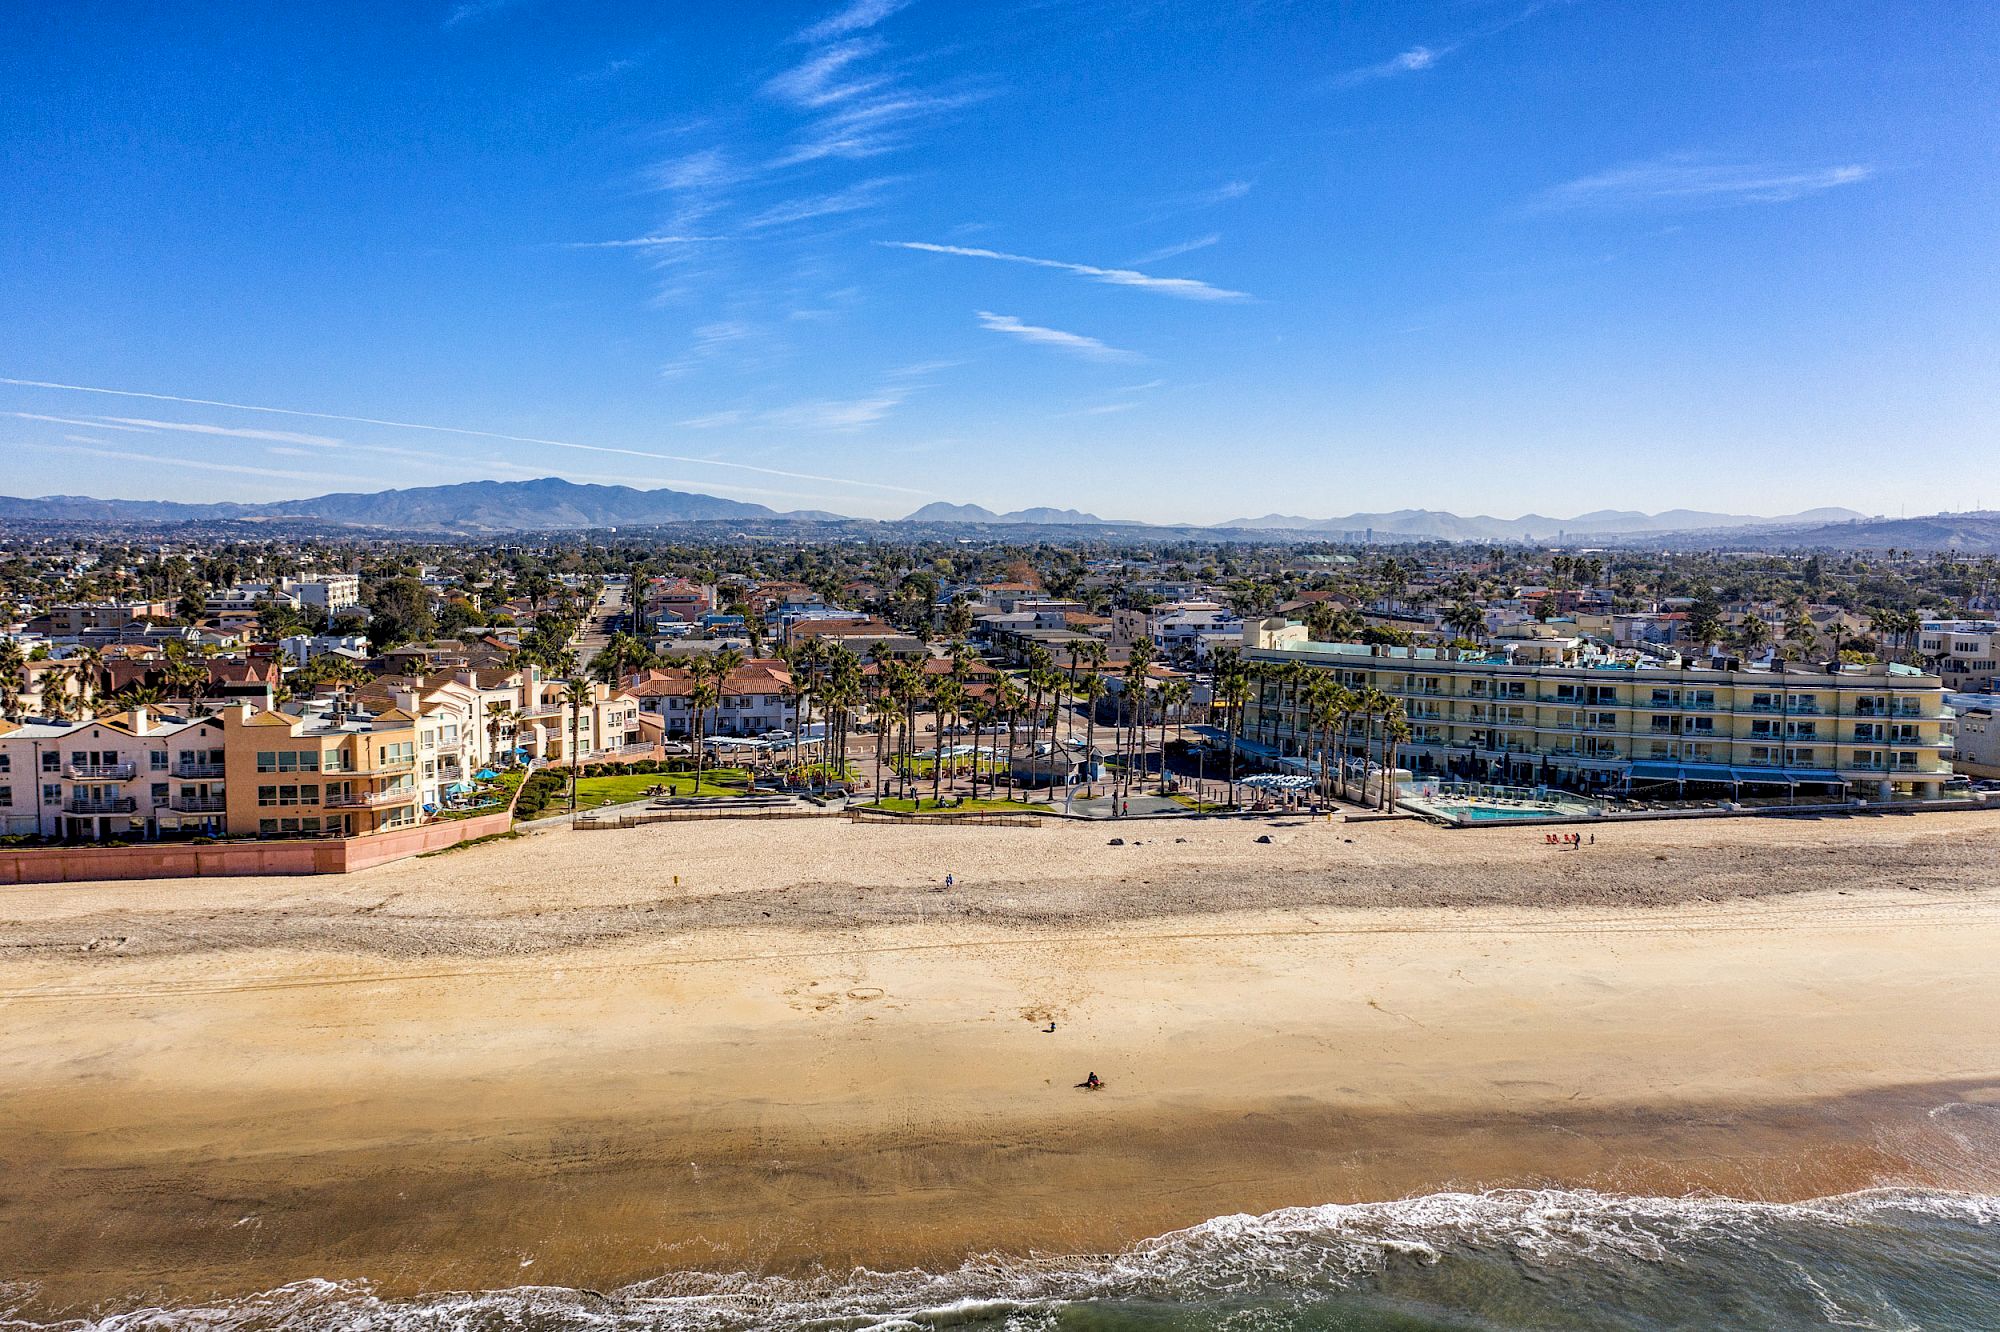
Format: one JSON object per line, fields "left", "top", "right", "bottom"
{"left": 0, "top": 810, "right": 514, "bottom": 884}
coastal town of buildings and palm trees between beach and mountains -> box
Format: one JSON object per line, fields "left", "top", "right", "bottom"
{"left": 0, "top": 538, "right": 2000, "bottom": 878}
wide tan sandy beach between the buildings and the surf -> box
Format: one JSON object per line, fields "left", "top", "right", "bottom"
{"left": 0, "top": 814, "right": 2000, "bottom": 1310}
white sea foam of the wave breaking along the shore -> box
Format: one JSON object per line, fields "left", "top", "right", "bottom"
{"left": 15, "top": 1188, "right": 2000, "bottom": 1332}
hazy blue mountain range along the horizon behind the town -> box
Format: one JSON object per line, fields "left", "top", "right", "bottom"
{"left": 0, "top": 476, "right": 2000, "bottom": 552}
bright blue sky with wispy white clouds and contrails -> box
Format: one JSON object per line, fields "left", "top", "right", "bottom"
{"left": 0, "top": 0, "right": 2000, "bottom": 522}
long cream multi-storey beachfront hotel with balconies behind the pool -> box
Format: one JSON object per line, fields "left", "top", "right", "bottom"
{"left": 1242, "top": 618, "right": 1952, "bottom": 800}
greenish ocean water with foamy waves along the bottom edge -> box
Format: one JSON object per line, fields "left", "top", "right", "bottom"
{"left": 0, "top": 1188, "right": 2000, "bottom": 1332}
